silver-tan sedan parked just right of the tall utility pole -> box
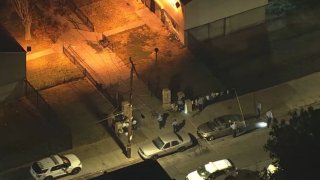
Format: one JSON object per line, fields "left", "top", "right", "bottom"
{"left": 138, "top": 132, "right": 193, "bottom": 159}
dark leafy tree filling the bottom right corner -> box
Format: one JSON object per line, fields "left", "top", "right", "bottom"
{"left": 265, "top": 108, "right": 320, "bottom": 180}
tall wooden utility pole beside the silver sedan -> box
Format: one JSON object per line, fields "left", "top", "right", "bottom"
{"left": 127, "top": 57, "right": 139, "bottom": 158}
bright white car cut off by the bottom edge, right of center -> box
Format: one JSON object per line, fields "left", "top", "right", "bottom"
{"left": 186, "top": 159, "right": 237, "bottom": 180}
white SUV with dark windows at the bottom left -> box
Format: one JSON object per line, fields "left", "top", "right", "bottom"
{"left": 30, "top": 154, "right": 82, "bottom": 180}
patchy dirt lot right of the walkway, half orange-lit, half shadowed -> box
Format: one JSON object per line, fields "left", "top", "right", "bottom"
{"left": 109, "top": 25, "right": 223, "bottom": 97}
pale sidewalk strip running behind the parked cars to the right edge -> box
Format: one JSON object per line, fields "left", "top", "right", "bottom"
{"left": 65, "top": 73, "right": 320, "bottom": 179}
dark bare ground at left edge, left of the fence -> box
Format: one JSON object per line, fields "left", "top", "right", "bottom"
{"left": 0, "top": 98, "right": 68, "bottom": 171}
